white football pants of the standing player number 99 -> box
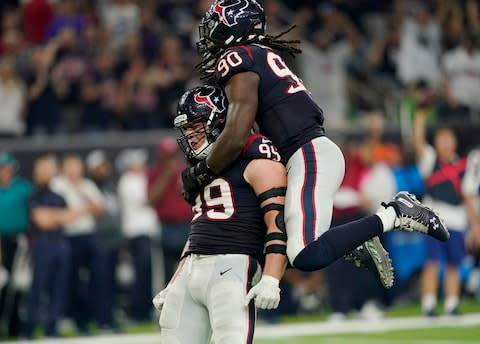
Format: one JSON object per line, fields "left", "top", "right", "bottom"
{"left": 159, "top": 254, "right": 261, "bottom": 344}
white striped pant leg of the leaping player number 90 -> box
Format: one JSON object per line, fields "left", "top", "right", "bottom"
{"left": 285, "top": 136, "right": 345, "bottom": 264}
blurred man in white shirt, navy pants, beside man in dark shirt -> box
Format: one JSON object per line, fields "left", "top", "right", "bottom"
{"left": 51, "top": 155, "right": 105, "bottom": 333}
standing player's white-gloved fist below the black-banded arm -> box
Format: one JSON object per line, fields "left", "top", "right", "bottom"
{"left": 245, "top": 275, "right": 280, "bottom": 309}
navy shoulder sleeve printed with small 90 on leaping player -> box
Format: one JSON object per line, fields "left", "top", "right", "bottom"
{"left": 215, "top": 44, "right": 267, "bottom": 84}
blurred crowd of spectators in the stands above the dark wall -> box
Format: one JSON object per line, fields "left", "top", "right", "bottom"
{"left": 0, "top": 0, "right": 480, "bottom": 137}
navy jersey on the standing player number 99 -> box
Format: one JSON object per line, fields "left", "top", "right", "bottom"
{"left": 188, "top": 135, "right": 280, "bottom": 260}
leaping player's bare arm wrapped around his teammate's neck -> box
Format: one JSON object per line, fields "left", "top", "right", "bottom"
{"left": 207, "top": 72, "right": 259, "bottom": 173}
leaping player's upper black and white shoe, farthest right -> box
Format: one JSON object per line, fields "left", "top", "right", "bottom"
{"left": 382, "top": 191, "right": 450, "bottom": 241}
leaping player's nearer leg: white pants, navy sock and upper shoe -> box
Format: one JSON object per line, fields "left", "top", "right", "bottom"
{"left": 285, "top": 137, "right": 448, "bottom": 271}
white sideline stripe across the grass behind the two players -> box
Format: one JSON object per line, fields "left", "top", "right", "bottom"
{"left": 3, "top": 314, "right": 480, "bottom": 344}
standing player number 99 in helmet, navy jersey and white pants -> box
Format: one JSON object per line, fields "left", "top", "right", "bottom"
{"left": 153, "top": 86, "right": 287, "bottom": 344}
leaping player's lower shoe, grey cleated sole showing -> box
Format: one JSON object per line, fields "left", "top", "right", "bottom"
{"left": 345, "top": 237, "right": 394, "bottom": 289}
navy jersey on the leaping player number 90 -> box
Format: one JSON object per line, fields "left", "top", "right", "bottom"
{"left": 215, "top": 44, "right": 324, "bottom": 162}
